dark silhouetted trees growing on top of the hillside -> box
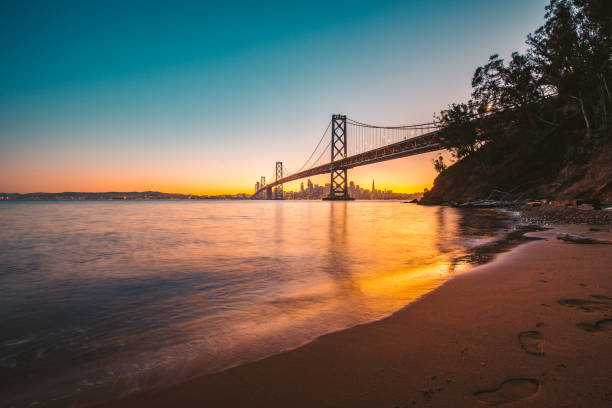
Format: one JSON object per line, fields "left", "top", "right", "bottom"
{"left": 437, "top": 0, "right": 612, "bottom": 163}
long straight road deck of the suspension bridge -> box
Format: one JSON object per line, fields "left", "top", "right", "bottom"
{"left": 254, "top": 130, "right": 444, "bottom": 196}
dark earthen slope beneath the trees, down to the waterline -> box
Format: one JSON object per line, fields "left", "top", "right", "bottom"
{"left": 421, "top": 132, "right": 612, "bottom": 204}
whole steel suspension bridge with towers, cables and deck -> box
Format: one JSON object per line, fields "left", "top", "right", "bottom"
{"left": 252, "top": 115, "right": 444, "bottom": 200}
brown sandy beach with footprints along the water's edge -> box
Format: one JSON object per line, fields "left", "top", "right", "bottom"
{"left": 98, "top": 225, "right": 612, "bottom": 408}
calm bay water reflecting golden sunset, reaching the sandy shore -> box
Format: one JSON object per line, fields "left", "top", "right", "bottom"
{"left": 0, "top": 201, "right": 509, "bottom": 407}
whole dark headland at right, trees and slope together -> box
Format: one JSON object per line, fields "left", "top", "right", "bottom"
{"left": 424, "top": 0, "right": 612, "bottom": 203}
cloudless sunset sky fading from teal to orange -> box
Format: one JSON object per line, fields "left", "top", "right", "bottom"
{"left": 0, "top": 0, "right": 548, "bottom": 194}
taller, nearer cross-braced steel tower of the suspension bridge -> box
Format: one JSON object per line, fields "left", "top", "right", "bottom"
{"left": 324, "top": 115, "right": 353, "bottom": 200}
